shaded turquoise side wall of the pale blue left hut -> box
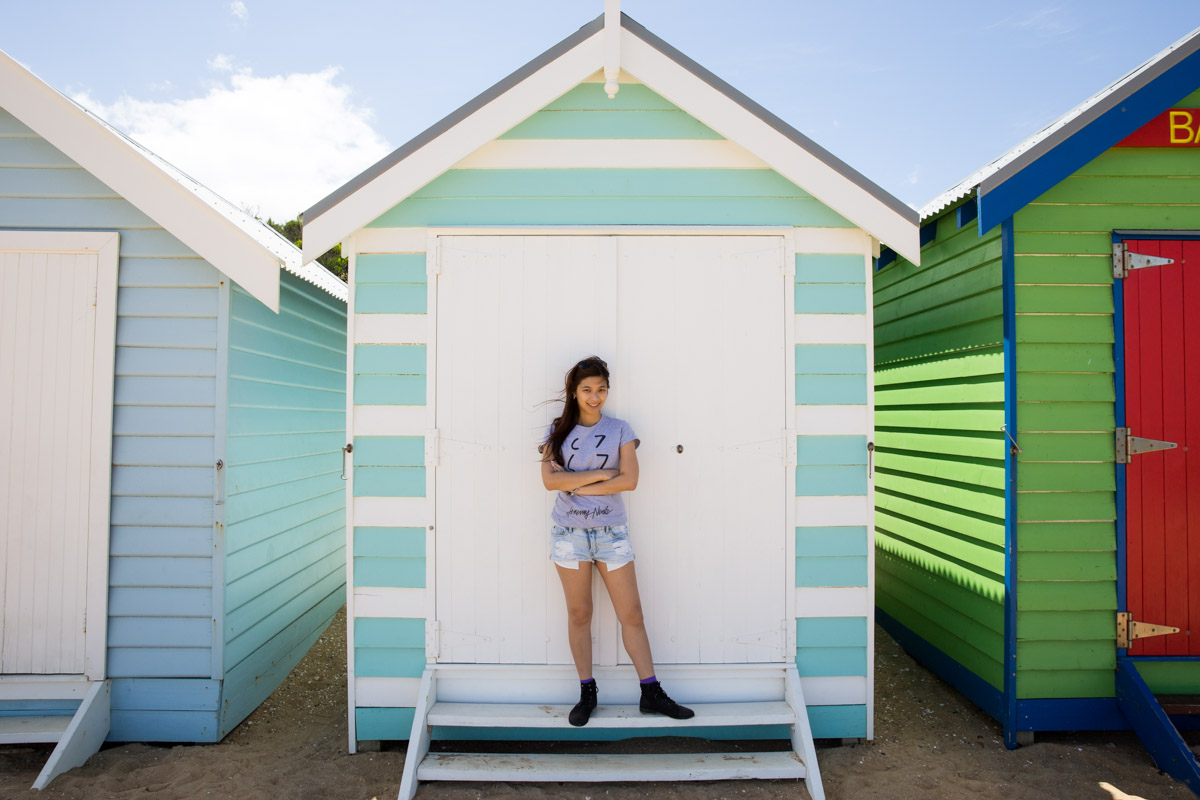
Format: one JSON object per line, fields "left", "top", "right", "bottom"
{"left": 220, "top": 272, "right": 346, "bottom": 736}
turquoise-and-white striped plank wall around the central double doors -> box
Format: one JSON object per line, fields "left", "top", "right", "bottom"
{"left": 350, "top": 77, "right": 872, "bottom": 740}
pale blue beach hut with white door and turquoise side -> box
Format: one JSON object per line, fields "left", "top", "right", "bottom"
{"left": 0, "top": 47, "right": 347, "bottom": 786}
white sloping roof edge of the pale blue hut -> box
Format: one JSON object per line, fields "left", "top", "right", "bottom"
{"left": 0, "top": 52, "right": 348, "bottom": 312}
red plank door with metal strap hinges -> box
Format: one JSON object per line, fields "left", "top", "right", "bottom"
{"left": 1124, "top": 240, "right": 1200, "bottom": 656}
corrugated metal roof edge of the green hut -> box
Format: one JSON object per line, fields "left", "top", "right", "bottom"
{"left": 920, "top": 28, "right": 1200, "bottom": 219}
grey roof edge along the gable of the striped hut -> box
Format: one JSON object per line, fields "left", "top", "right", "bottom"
{"left": 304, "top": 12, "right": 918, "bottom": 222}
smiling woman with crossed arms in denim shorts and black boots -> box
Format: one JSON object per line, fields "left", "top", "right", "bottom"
{"left": 541, "top": 356, "right": 694, "bottom": 727}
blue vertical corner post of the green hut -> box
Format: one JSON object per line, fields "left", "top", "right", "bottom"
{"left": 1000, "top": 217, "right": 1020, "bottom": 750}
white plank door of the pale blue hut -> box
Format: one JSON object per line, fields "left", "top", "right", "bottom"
{"left": 0, "top": 233, "right": 116, "bottom": 679}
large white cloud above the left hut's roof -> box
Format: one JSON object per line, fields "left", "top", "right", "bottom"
{"left": 76, "top": 67, "right": 391, "bottom": 219}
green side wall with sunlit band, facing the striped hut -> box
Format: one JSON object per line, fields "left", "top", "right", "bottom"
{"left": 875, "top": 210, "right": 1004, "bottom": 690}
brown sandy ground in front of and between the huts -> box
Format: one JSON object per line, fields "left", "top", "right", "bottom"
{"left": 0, "top": 606, "right": 1193, "bottom": 800}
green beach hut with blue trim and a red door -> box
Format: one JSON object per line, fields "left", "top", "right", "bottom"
{"left": 874, "top": 31, "right": 1200, "bottom": 788}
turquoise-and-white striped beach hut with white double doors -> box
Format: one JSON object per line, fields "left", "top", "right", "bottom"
{"left": 305, "top": 4, "right": 918, "bottom": 796}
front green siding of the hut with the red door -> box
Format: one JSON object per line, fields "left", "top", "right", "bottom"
{"left": 1013, "top": 100, "right": 1200, "bottom": 698}
